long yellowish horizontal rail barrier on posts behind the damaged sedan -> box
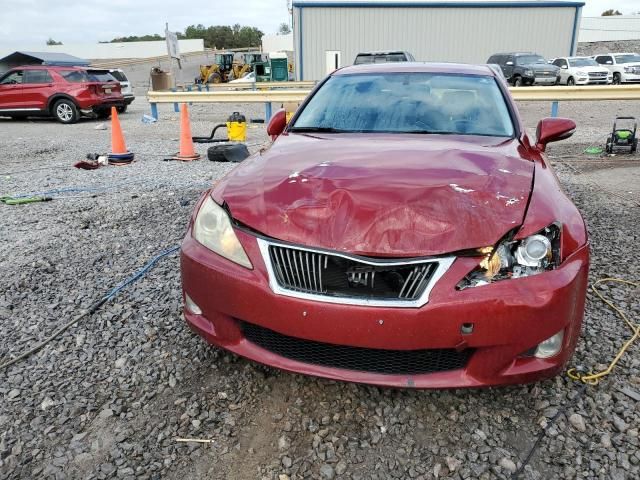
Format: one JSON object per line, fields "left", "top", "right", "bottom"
{"left": 147, "top": 82, "right": 640, "bottom": 121}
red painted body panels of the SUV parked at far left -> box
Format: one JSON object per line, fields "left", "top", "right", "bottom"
{"left": 0, "top": 65, "right": 125, "bottom": 120}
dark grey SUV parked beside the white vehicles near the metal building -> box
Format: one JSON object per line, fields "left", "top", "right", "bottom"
{"left": 487, "top": 53, "right": 560, "bottom": 87}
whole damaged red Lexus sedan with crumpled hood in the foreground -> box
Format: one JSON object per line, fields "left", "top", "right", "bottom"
{"left": 181, "top": 63, "right": 589, "bottom": 388}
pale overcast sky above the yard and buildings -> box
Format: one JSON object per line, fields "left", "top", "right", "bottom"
{"left": 0, "top": 0, "right": 640, "bottom": 48}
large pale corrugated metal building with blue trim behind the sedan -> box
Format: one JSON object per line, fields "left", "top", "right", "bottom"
{"left": 293, "top": 0, "right": 584, "bottom": 80}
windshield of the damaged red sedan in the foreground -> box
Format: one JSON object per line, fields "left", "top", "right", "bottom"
{"left": 289, "top": 72, "right": 514, "bottom": 137}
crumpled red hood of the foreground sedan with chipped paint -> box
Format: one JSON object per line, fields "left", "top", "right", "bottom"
{"left": 213, "top": 134, "right": 534, "bottom": 257}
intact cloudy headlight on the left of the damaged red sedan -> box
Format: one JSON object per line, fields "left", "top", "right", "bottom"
{"left": 193, "top": 196, "right": 253, "bottom": 268}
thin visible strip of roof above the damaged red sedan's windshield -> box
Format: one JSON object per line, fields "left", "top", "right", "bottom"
{"left": 332, "top": 62, "right": 496, "bottom": 77}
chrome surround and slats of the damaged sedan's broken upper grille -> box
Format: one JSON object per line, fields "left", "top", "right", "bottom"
{"left": 257, "top": 238, "right": 455, "bottom": 308}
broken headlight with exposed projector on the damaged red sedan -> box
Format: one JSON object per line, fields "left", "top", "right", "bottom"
{"left": 457, "top": 223, "right": 560, "bottom": 290}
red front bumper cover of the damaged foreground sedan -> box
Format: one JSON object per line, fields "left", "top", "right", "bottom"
{"left": 181, "top": 230, "right": 589, "bottom": 388}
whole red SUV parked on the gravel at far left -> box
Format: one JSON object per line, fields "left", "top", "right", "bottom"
{"left": 0, "top": 65, "right": 125, "bottom": 123}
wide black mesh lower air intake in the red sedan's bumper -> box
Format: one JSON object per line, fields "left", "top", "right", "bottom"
{"left": 241, "top": 322, "right": 474, "bottom": 375}
